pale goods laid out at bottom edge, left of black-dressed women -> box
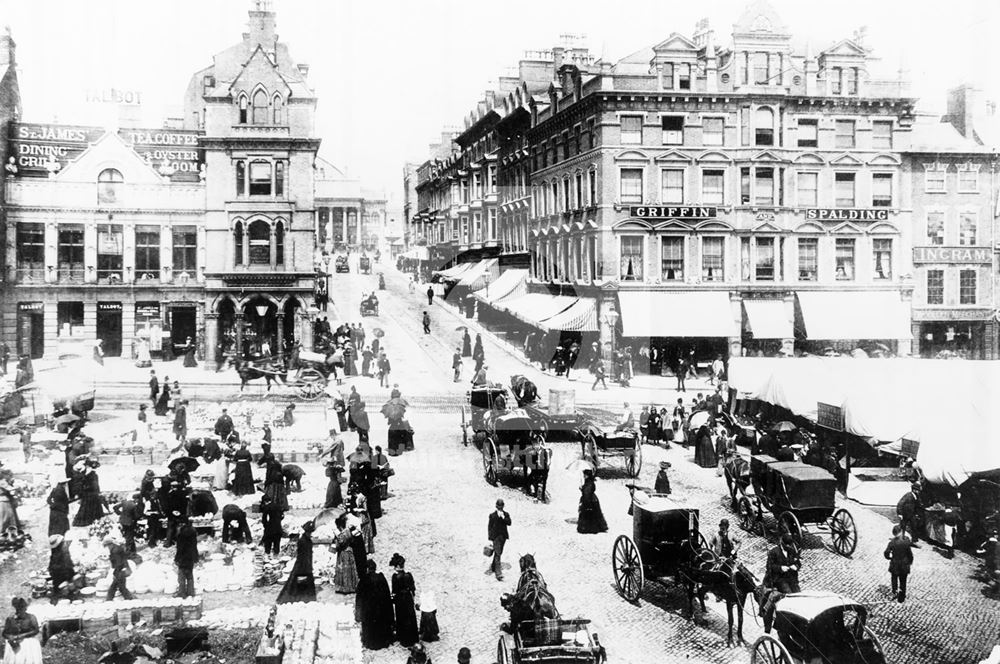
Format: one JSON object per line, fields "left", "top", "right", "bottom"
{"left": 274, "top": 602, "right": 362, "bottom": 664}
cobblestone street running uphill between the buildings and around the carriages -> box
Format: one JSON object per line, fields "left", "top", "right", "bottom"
{"left": 2, "top": 264, "right": 1000, "bottom": 664}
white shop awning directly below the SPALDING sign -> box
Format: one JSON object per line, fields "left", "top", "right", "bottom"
{"left": 796, "top": 291, "right": 912, "bottom": 340}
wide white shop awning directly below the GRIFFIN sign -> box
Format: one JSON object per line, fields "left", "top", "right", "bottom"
{"left": 618, "top": 291, "right": 739, "bottom": 337}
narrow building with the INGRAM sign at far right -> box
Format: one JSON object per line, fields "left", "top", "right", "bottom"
{"left": 904, "top": 85, "right": 1000, "bottom": 359}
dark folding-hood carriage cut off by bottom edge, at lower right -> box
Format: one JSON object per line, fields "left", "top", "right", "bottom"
{"left": 750, "top": 593, "right": 886, "bottom": 664}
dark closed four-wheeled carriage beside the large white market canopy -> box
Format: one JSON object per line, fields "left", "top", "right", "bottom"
{"left": 737, "top": 454, "right": 858, "bottom": 556}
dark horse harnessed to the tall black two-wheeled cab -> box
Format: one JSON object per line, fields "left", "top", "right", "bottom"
{"left": 682, "top": 549, "right": 758, "bottom": 647}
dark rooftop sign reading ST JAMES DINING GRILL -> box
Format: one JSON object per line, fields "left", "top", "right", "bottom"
{"left": 10, "top": 124, "right": 104, "bottom": 177}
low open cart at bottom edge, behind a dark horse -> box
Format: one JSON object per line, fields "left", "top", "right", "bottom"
{"left": 497, "top": 618, "right": 600, "bottom": 664}
